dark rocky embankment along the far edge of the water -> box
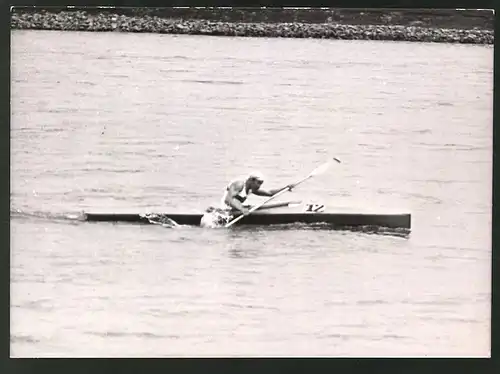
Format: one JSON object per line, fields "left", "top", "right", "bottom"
{"left": 11, "top": 9, "right": 494, "bottom": 44}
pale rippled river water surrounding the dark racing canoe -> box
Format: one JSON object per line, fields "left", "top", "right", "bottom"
{"left": 11, "top": 31, "right": 493, "bottom": 357}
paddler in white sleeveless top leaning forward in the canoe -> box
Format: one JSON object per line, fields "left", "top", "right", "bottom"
{"left": 222, "top": 171, "right": 295, "bottom": 215}
